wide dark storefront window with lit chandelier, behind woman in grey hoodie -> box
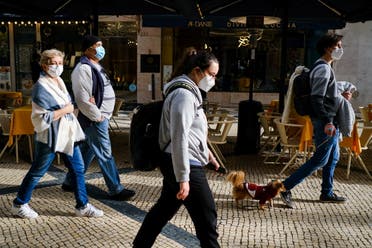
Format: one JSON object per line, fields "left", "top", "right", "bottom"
{"left": 175, "top": 28, "right": 305, "bottom": 92}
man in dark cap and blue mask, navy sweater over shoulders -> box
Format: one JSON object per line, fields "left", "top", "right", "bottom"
{"left": 62, "top": 35, "right": 135, "bottom": 200}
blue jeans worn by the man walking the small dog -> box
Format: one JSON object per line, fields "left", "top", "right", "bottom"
{"left": 284, "top": 119, "right": 340, "bottom": 195}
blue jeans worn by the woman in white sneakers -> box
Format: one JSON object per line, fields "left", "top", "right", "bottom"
{"left": 13, "top": 141, "right": 88, "bottom": 208}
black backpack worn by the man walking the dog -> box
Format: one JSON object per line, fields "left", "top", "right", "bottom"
{"left": 293, "top": 60, "right": 332, "bottom": 115}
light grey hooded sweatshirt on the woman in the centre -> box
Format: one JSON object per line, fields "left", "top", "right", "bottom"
{"left": 159, "top": 75, "right": 209, "bottom": 182}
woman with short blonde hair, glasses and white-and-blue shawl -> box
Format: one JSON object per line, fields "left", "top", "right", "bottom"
{"left": 11, "top": 49, "right": 103, "bottom": 219}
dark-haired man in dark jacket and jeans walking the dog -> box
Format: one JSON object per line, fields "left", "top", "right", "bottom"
{"left": 281, "top": 34, "right": 351, "bottom": 208}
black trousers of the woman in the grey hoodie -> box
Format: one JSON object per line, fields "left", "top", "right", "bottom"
{"left": 133, "top": 154, "right": 220, "bottom": 248}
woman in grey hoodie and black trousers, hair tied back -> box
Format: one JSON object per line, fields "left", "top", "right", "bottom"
{"left": 133, "top": 51, "right": 220, "bottom": 248}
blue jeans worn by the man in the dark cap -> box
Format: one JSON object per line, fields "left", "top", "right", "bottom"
{"left": 64, "top": 119, "right": 124, "bottom": 195}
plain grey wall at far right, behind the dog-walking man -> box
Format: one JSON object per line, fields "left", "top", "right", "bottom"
{"left": 334, "top": 21, "right": 372, "bottom": 110}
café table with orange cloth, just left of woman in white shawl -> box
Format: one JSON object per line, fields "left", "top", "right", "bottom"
{"left": 8, "top": 105, "right": 34, "bottom": 163}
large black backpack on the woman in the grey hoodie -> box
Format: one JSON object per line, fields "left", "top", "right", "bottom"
{"left": 129, "top": 82, "right": 197, "bottom": 171}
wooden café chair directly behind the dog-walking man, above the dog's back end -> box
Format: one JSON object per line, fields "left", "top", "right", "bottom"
{"left": 274, "top": 118, "right": 309, "bottom": 174}
